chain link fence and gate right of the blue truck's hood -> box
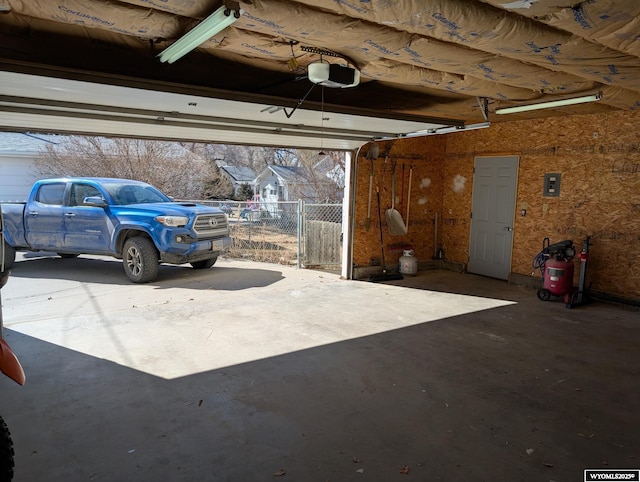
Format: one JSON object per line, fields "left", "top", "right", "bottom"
{"left": 181, "top": 200, "right": 342, "bottom": 269}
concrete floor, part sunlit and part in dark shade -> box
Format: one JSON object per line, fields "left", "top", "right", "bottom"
{"left": 0, "top": 257, "right": 640, "bottom": 482}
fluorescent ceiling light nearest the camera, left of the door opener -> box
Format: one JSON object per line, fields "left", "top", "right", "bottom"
{"left": 158, "top": 5, "right": 244, "bottom": 64}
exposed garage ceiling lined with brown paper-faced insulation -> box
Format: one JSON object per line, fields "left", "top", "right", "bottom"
{"left": 0, "top": 0, "right": 640, "bottom": 139}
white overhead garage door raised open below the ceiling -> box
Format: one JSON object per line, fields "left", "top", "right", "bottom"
{"left": 0, "top": 71, "right": 446, "bottom": 150}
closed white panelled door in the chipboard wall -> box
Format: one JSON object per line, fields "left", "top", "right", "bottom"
{"left": 468, "top": 156, "right": 519, "bottom": 280}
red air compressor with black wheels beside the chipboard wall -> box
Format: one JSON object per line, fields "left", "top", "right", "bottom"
{"left": 533, "top": 238, "right": 576, "bottom": 304}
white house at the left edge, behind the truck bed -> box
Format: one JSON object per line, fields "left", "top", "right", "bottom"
{"left": 0, "top": 132, "right": 56, "bottom": 202}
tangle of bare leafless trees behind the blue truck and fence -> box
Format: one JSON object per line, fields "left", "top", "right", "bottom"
{"left": 36, "top": 136, "right": 345, "bottom": 201}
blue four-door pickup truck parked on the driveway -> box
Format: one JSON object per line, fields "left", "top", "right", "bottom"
{"left": 0, "top": 178, "right": 231, "bottom": 283}
